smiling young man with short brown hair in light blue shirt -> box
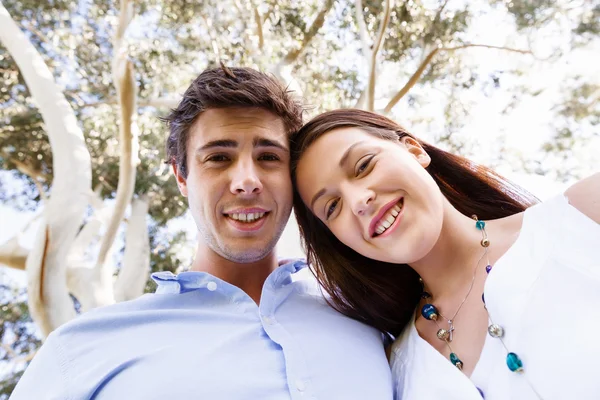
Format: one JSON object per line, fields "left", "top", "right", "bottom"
{"left": 11, "top": 67, "right": 392, "bottom": 400}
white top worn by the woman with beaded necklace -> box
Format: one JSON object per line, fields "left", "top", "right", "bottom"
{"left": 390, "top": 195, "right": 600, "bottom": 400}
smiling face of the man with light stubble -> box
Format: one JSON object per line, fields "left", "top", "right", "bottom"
{"left": 174, "top": 108, "right": 292, "bottom": 263}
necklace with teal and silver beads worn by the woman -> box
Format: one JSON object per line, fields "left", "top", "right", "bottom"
{"left": 420, "top": 215, "right": 542, "bottom": 399}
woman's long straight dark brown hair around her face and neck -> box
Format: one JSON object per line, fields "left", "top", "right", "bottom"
{"left": 291, "top": 109, "right": 537, "bottom": 336}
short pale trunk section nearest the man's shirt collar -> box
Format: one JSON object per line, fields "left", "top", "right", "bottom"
{"left": 114, "top": 196, "right": 150, "bottom": 302}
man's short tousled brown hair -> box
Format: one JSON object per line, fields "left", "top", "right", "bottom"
{"left": 163, "top": 65, "right": 304, "bottom": 177}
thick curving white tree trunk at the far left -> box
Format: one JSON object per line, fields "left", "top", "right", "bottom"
{"left": 0, "top": 3, "right": 92, "bottom": 335}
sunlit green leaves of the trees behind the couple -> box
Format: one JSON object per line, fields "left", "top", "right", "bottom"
{"left": 0, "top": 0, "right": 600, "bottom": 394}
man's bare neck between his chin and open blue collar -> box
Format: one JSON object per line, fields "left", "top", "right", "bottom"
{"left": 190, "top": 243, "right": 278, "bottom": 304}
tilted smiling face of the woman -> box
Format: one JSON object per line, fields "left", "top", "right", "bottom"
{"left": 296, "top": 128, "right": 444, "bottom": 264}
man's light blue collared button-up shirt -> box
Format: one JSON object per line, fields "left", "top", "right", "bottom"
{"left": 11, "top": 261, "right": 392, "bottom": 400}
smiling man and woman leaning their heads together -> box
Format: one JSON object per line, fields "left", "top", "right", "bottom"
{"left": 11, "top": 67, "right": 600, "bottom": 400}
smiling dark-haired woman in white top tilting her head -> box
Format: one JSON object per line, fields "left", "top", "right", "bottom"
{"left": 292, "top": 110, "right": 600, "bottom": 400}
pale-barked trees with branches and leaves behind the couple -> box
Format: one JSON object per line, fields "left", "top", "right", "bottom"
{"left": 0, "top": 0, "right": 600, "bottom": 399}
